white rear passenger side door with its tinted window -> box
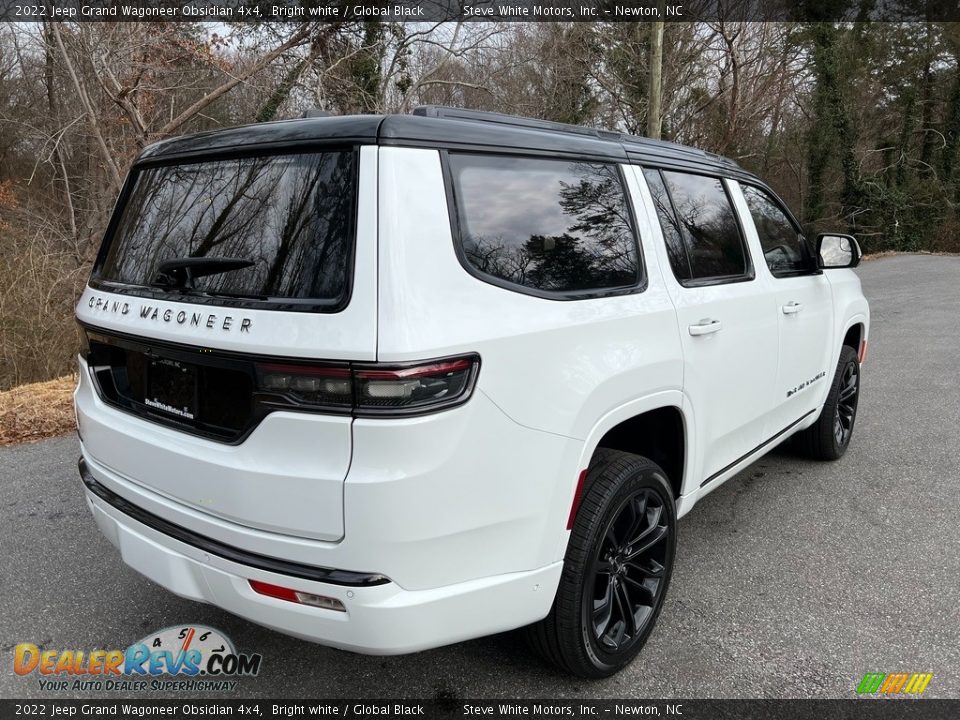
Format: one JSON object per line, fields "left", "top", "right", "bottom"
{"left": 643, "top": 168, "right": 778, "bottom": 485}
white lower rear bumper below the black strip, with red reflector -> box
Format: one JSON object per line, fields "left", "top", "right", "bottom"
{"left": 86, "top": 470, "right": 563, "bottom": 655}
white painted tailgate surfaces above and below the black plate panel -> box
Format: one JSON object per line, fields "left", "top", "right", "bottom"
{"left": 77, "top": 147, "right": 377, "bottom": 540}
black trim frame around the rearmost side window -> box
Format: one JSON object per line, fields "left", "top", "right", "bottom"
{"left": 439, "top": 147, "right": 649, "bottom": 301}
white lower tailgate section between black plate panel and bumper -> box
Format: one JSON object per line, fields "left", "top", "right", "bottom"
{"left": 74, "top": 359, "right": 351, "bottom": 540}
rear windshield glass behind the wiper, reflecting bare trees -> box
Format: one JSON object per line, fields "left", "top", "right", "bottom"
{"left": 95, "top": 150, "right": 357, "bottom": 310}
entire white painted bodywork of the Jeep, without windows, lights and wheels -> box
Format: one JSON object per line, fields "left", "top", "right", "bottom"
{"left": 75, "top": 147, "right": 869, "bottom": 654}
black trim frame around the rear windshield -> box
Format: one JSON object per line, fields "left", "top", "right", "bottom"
{"left": 87, "top": 141, "right": 361, "bottom": 315}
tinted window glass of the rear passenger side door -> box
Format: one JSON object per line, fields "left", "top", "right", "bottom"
{"left": 651, "top": 170, "right": 750, "bottom": 282}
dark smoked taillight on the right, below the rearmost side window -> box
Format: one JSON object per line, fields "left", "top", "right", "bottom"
{"left": 256, "top": 355, "right": 480, "bottom": 416}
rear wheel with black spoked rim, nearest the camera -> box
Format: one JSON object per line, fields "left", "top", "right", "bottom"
{"left": 526, "top": 448, "right": 677, "bottom": 678}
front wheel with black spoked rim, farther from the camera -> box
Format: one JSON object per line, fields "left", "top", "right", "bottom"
{"left": 794, "top": 345, "right": 860, "bottom": 460}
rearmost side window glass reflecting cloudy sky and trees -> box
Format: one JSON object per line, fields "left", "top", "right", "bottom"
{"left": 448, "top": 153, "right": 642, "bottom": 297}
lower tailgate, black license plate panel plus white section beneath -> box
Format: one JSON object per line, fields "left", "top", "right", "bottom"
{"left": 77, "top": 329, "right": 352, "bottom": 540}
